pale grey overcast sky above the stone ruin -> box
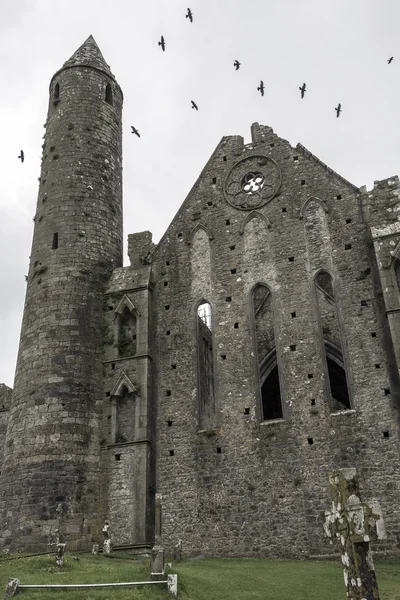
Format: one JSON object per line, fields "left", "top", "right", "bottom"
{"left": 0, "top": 0, "right": 400, "bottom": 386}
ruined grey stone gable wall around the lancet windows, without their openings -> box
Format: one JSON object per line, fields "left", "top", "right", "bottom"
{"left": 153, "top": 125, "right": 400, "bottom": 556}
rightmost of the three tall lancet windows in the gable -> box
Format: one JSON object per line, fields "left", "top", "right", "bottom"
{"left": 315, "top": 271, "right": 351, "bottom": 411}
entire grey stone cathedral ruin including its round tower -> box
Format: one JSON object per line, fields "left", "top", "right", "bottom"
{"left": 0, "top": 37, "right": 400, "bottom": 557}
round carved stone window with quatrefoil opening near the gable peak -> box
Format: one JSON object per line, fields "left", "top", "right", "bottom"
{"left": 224, "top": 155, "right": 282, "bottom": 210}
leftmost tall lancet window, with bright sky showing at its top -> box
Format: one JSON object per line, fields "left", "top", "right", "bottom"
{"left": 196, "top": 301, "right": 216, "bottom": 429}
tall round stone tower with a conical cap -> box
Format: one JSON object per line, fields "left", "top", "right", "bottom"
{"left": 0, "top": 36, "right": 123, "bottom": 551}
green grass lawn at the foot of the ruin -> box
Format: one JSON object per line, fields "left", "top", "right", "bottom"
{"left": 0, "top": 554, "right": 400, "bottom": 600}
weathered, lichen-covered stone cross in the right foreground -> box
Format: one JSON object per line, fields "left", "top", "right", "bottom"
{"left": 324, "top": 469, "right": 386, "bottom": 600}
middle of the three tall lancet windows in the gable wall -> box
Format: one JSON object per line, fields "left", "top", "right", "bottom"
{"left": 252, "top": 284, "right": 283, "bottom": 421}
